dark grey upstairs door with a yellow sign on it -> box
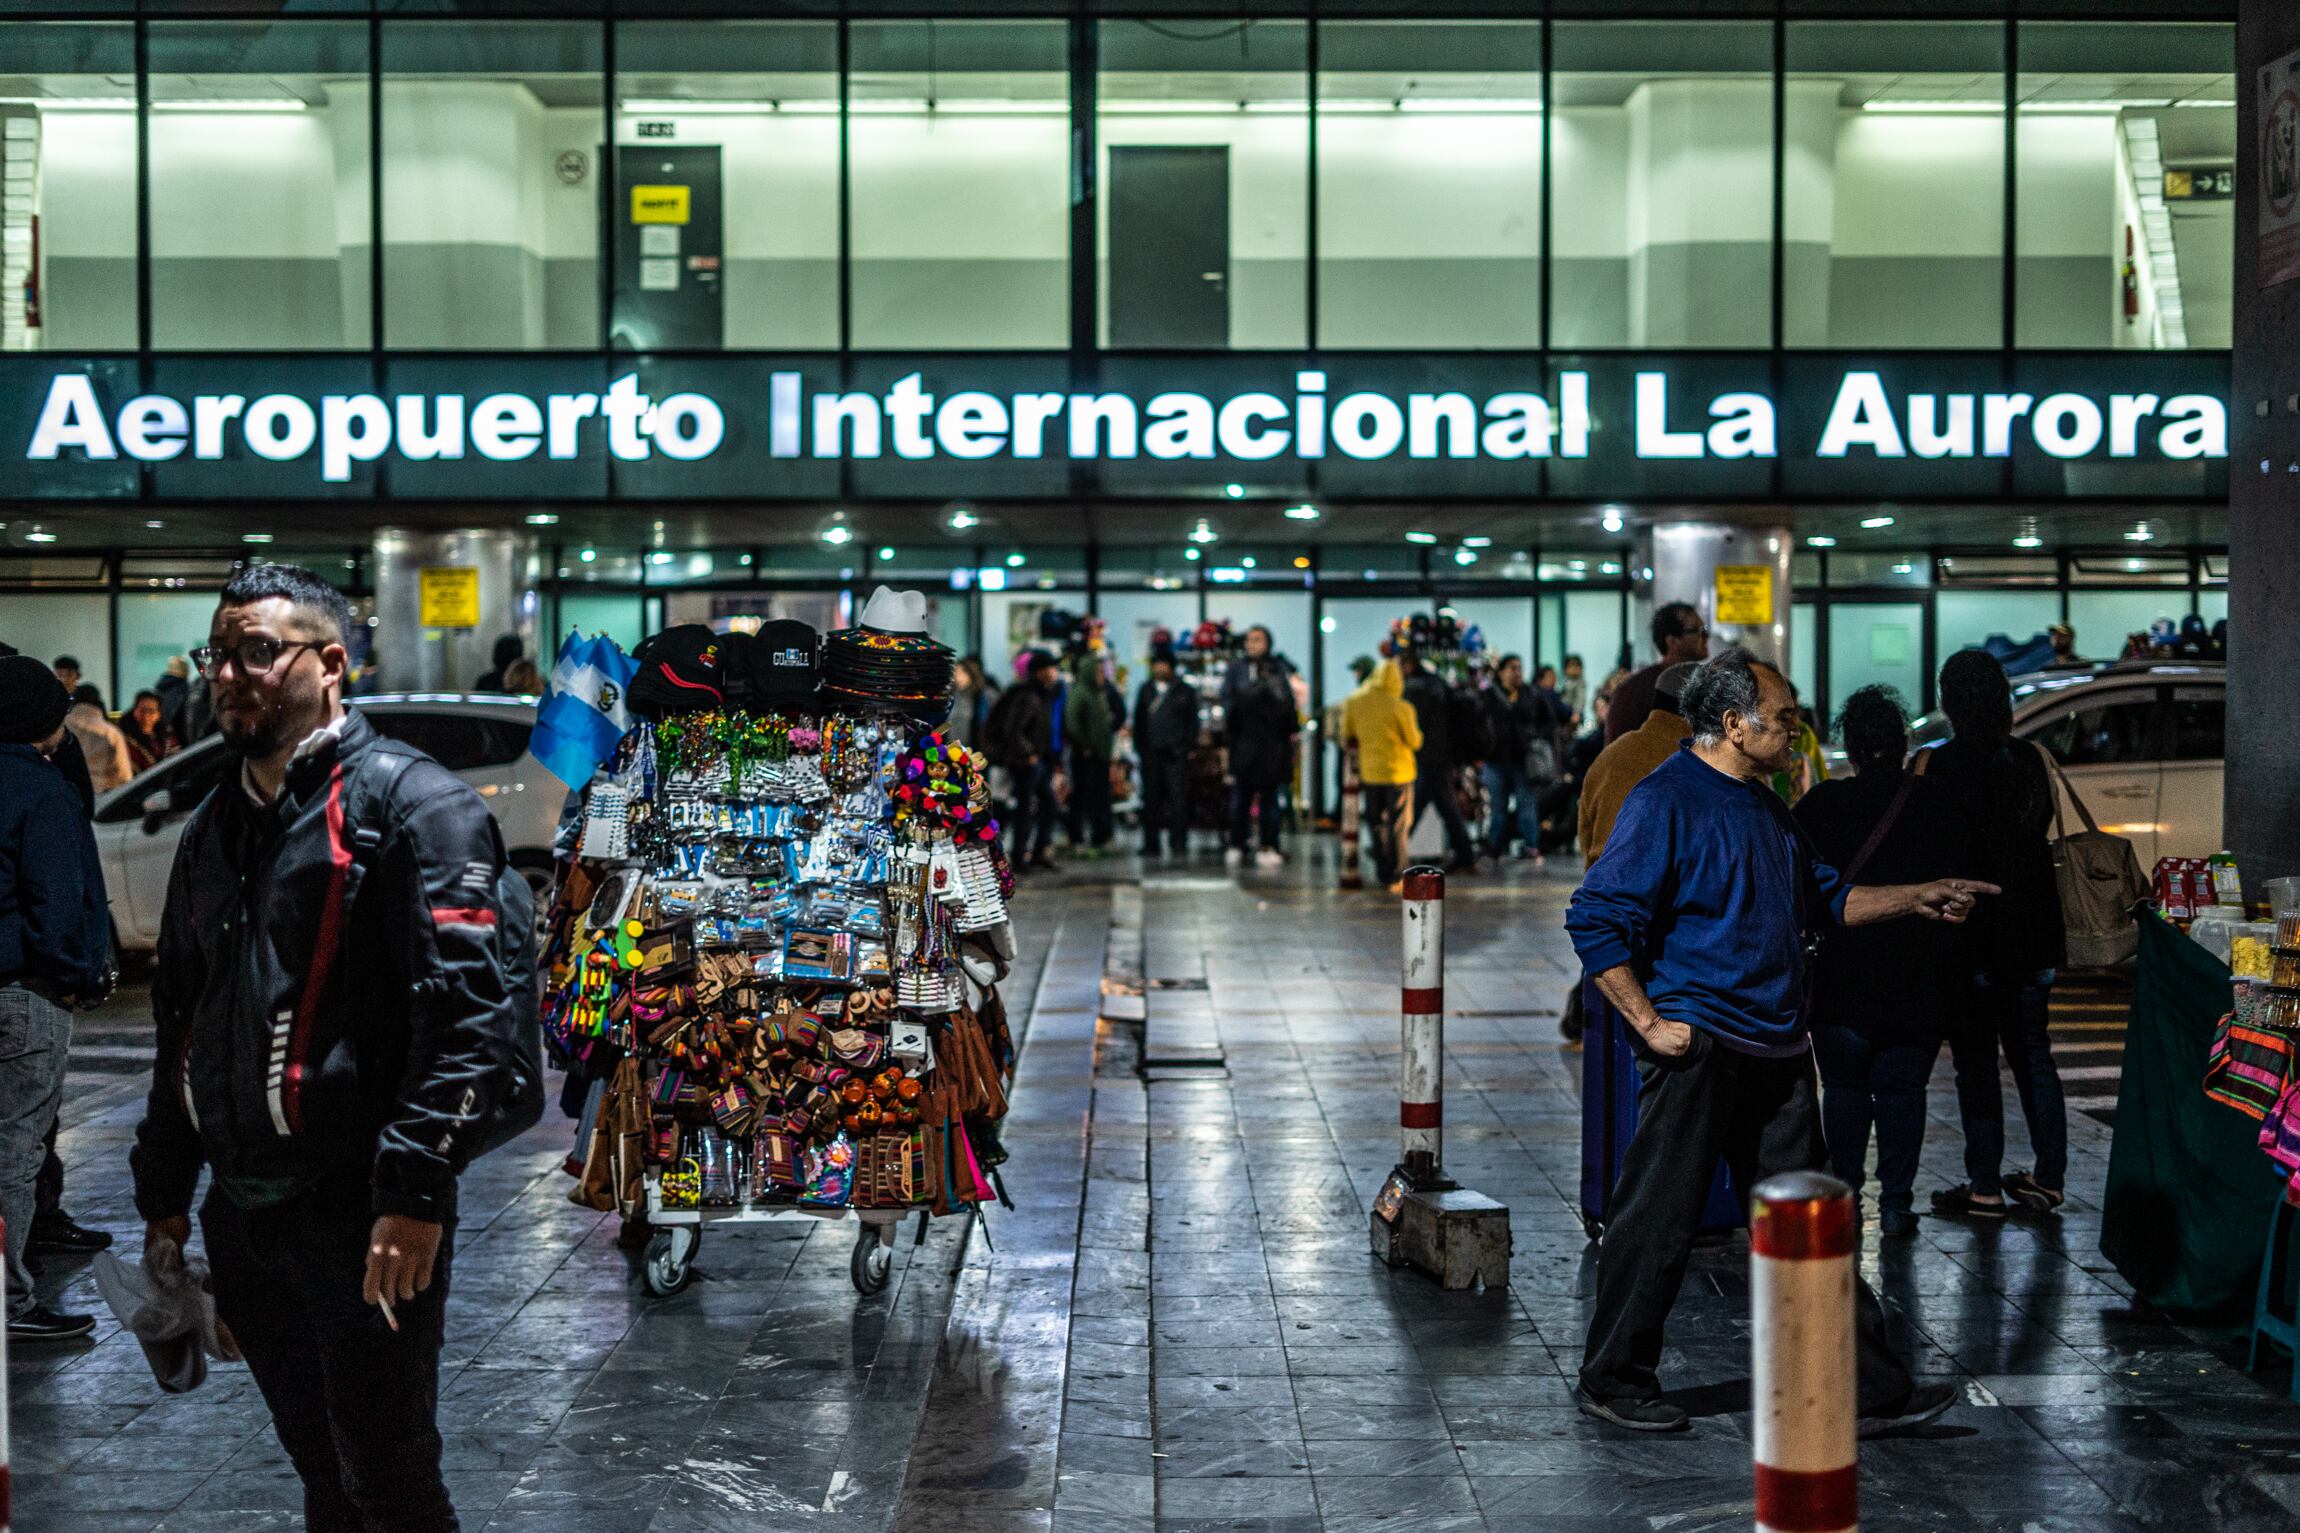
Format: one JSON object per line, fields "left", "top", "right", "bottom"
{"left": 614, "top": 145, "right": 727, "bottom": 352}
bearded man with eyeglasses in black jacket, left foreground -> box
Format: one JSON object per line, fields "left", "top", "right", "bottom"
{"left": 133, "top": 565, "right": 515, "bottom": 1533}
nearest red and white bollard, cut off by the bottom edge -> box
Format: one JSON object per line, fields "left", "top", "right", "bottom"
{"left": 1748, "top": 1172, "right": 1861, "bottom": 1533}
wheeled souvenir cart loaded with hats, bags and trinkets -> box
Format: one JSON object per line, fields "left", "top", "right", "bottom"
{"left": 545, "top": 588, "right": 1014, "bottom": 1296}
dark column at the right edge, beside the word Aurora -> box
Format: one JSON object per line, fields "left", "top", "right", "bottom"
{"left": 2224, "top": 11, "right": 2300, "bottom": 892}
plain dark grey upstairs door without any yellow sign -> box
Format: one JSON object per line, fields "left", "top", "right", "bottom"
{"left": 1111, "top": 145, "right": 1231, "bottom": 347}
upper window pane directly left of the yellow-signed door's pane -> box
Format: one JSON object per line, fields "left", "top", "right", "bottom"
{"left": 384, "top": 21, "right": 605, "bottom": 352}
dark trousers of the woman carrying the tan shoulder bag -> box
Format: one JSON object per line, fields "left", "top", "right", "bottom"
{"left": 1948, "top": 970, "right": 2068, "bottom": 1197}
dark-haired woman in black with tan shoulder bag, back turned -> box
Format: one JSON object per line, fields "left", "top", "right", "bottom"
{"left": 1932, "top": 650, "right": 2068, "bottom": 1218}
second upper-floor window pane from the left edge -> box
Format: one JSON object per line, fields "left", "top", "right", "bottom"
{"left": 150, "top": 21, "right": 370, "bottom": 352}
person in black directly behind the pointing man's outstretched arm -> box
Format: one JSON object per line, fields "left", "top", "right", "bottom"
{"left": 1794, "top": 687, "right": 1971, "bottom": 1234}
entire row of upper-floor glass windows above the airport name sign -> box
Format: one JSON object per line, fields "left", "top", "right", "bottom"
{"left": 0, "top": 2, "right": 2236, "bottom": 352}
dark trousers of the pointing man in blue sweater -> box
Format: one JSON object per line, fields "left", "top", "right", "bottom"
{"left": 1580, "top": 1027, "right": 1911, "bottom": 1413}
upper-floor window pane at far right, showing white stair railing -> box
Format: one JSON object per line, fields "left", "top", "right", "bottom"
{"left": 2015, "top": 23, "right": 2236, "bottom": 349}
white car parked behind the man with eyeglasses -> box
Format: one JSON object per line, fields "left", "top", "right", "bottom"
{"left": 97, "top": 692, "right": 566, "bottom": 952}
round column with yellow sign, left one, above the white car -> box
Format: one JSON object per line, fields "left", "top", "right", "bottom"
{"left": 373, "top": 526, "right": 538, "bottom": 692}
